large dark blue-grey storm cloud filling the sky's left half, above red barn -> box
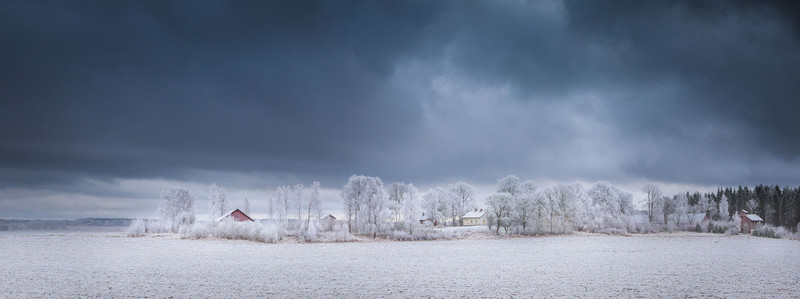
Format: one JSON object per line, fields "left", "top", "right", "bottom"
{"left": 0, "top": 1, "right": 440, "bottom": 188}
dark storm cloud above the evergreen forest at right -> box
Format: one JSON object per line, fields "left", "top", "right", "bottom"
{"left": 570, "top": 1, "right": 800, "bottom": 184}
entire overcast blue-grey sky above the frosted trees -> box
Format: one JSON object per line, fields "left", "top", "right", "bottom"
{"left": 0, "top": 0, "right": 800, "bottom": 218}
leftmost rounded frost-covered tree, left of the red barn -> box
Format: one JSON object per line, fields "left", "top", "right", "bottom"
{"left": 158, "top": 187, "right": 197, "bottom": 233}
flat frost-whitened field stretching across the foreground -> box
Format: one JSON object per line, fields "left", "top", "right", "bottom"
{"left": 0, "top": 232, "right": 800, "bottom": 298}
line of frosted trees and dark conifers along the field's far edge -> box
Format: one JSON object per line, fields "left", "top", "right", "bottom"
{"left": 145, "top": 175, "right": 800, "bottom": 237}
